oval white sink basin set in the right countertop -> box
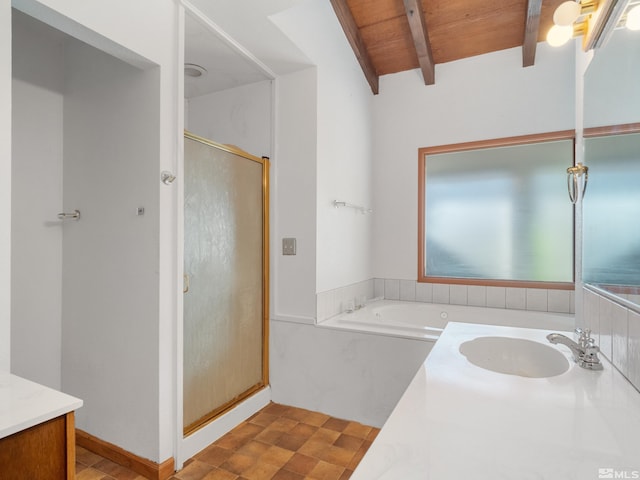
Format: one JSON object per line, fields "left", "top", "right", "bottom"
{"left": 460, "top": 337, "right": 569, "bottom": 378}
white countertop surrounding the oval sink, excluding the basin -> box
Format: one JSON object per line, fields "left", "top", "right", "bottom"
{"left": 351, "top": 323, "right": 640, "bottom": 480}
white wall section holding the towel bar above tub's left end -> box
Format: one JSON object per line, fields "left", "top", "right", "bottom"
{"left": 277, "top": 0, "right": 373, "bottom": 292}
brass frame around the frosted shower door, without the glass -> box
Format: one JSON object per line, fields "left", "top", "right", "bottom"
{"left": 183, "top": 130, "right": 269, "bottom": 437}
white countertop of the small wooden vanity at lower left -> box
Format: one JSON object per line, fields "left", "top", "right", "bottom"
{"left": 0, "top": 372, "right": 82, "bottom": 438}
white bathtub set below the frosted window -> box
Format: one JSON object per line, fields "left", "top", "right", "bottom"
{"left": 318, "top": 300, "right": 574, "bottom": 342}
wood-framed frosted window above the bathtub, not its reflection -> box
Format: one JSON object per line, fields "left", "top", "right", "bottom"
{"left": 418, "top": 131, "right": 574, "bottom": 289}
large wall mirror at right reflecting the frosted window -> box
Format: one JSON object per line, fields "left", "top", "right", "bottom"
{"left": 583, "top": 22, "right": 640, "bottom": 309}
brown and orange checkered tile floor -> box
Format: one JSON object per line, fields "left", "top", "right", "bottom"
{"left": 76, "top": 403, "right": 379, "bottom": 480}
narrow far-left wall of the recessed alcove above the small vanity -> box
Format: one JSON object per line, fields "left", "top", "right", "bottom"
{"left": 11, "top": 12, "right": 64, "bottom": 389}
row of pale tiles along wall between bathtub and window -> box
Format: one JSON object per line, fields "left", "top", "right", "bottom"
{"left": 316, "top": 278, "right": 575, "bottom": 322}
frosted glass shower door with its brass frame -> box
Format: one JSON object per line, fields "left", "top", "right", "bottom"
{"left": 183, "top": 133, "right": 269, "bottom": 435}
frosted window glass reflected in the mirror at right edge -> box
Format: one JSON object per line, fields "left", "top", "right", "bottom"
{"left": 582, "top": 134, "right": 640, "bottom": 286}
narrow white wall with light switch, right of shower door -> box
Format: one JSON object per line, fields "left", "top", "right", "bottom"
{"left": 271, "top": 68, "right": 318, "bottom": 322}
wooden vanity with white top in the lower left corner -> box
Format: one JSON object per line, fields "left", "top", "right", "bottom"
{"left": 0, "top": 373, "right": 82, "bottom": 480}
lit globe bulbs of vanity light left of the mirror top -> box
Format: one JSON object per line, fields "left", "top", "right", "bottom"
{"left": 547, "top": 0, "right": 598, "bottom": 47}
